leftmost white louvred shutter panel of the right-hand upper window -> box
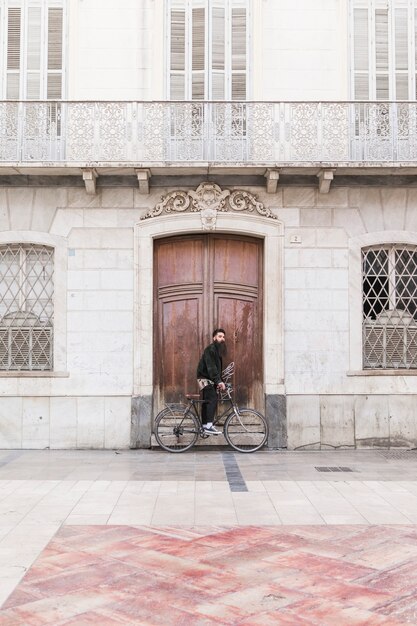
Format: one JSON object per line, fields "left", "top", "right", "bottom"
{"left": 353, "top": 8, "right": 369, "bottom": 100}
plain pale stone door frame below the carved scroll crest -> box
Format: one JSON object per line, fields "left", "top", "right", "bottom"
{"left": 133, "top": 212, "right": 285, "bottom": 400}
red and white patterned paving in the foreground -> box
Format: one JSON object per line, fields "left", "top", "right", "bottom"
{"left": 0, "top": 526, "right": 417, "bottom": 626}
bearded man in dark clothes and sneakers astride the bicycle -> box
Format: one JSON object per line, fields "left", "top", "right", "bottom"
{"left": 197, "top": 328, "right": 226, "bottom": 435}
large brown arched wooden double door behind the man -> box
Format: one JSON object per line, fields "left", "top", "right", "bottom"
{"left": 154, "top": 234, "right": 264, "bottom": 410}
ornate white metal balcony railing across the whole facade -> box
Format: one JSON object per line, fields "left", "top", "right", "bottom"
{"left": 0, "top": 101, "right": 417, "bottom": 166}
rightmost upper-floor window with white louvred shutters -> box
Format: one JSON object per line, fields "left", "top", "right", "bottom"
{"left": 351, "top": 0, "right": 417, "bottom": 100}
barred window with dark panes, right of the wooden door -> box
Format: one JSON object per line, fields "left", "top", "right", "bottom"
{"left": 362, "top": 244, "right": 417, "bottom": 369}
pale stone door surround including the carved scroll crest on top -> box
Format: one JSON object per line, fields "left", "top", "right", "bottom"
{"left": 131, "top": 183, "right": 286, "bottom": 448}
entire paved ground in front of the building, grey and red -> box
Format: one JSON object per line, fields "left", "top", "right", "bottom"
{"left": 0, "top": 449, "right": 417, "bottom": 626}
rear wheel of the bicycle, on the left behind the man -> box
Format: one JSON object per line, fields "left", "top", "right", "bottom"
{"left": 154, "top": 408, "right": 199, "bottom": 452}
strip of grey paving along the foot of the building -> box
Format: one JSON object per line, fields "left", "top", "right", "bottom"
{"left": 0, "top": 449, "right": 417, "bottom": 482}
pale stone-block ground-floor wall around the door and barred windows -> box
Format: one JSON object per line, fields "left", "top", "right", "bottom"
{"left": 0, "top": 179, "right": 417, "bottom": 449}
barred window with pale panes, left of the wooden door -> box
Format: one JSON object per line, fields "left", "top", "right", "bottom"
{"left": 0, "top": 244, "right": 54, "bottom": 371}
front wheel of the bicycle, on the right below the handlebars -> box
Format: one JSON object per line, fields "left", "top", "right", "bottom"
{"left": 224, "top": 409, "right": 268, "bottom": 452}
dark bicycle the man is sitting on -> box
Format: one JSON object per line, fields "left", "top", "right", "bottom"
{"left": 154, "top": 363, "right": 268, "bottom": 452}
